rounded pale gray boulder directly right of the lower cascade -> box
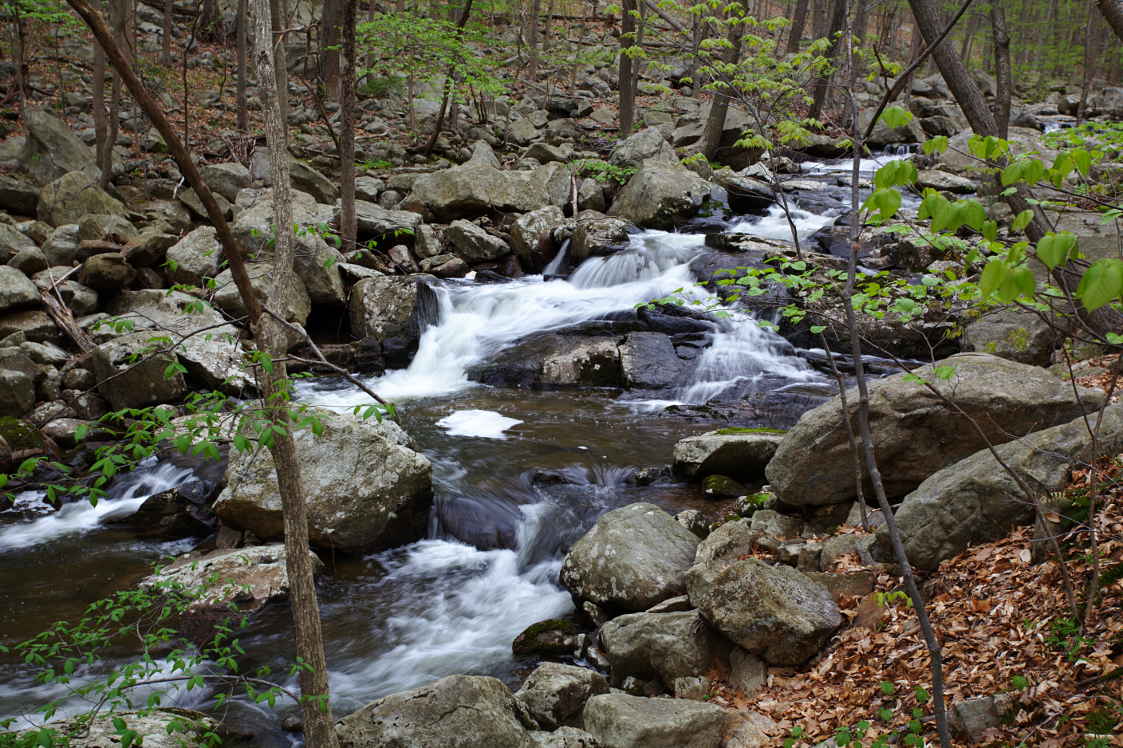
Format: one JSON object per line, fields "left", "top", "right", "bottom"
{"left": 562, "top": 503, "right": 699, "bottom": 612}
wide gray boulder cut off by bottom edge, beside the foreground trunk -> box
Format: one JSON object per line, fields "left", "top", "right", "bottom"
{"left": 336, "top": 675, "right": 535, "bottom": 748}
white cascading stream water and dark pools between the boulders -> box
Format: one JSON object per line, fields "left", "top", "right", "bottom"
{"left": 0, "top": 153, "right": 907, "bottom": 732}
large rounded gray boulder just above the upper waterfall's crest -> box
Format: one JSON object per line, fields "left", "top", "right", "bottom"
{"left": 609, "top": 162, "right": 713, "bottom": 229}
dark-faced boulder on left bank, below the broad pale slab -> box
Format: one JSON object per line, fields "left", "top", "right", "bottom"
{"left": 93, "top": 331, "right": 188, "bottom": 410}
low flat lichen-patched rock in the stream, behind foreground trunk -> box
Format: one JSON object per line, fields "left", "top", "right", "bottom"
{"left": 140, "top": 542, "right": 323, "bottom": 621}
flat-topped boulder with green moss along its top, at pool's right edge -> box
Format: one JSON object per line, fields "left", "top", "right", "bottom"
{"left": 674, "top": 428, "right": 784, "bottom": 481}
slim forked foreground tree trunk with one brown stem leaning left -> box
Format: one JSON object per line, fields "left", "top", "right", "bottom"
{"left": 67, "top": 0, "right": 338, "bottom": 748}
